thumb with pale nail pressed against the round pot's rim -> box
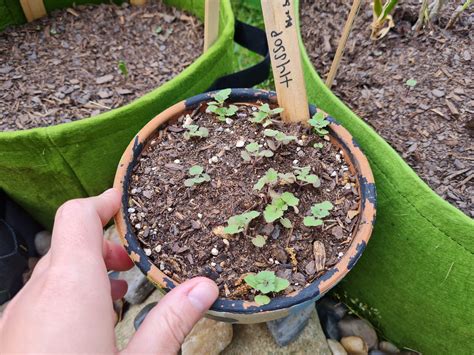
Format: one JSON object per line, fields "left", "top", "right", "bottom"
{"left": 125, "top": 277, "right": 219, "bottom": 354}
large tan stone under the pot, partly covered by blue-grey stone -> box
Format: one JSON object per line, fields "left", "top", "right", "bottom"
{"left": 222, "top": 311, "right": 331, "bottom": 355}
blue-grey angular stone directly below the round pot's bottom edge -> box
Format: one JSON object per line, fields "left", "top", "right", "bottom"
{"left": 267, "top": 302, "right": 314, "bottom": 346}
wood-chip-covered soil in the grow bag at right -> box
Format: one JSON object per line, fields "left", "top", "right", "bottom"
{"left": 301, "top": 0, "right": 474, "bottom": 217}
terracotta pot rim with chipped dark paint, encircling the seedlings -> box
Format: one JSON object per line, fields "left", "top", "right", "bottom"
{"left": 114, "top": 89, "right": 376, "bottom": 323}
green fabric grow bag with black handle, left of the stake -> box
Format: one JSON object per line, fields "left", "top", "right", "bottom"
{"left": 0, "top": 0, "right": 234, "bottom": 227}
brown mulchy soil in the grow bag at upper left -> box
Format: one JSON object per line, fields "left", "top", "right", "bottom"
{"left": 0, "top": 2, "right": 203, "bottom": 131}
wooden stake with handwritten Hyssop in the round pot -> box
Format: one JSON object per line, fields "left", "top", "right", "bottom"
{"left": 262, "top": 0, "right": 309, "bottom": 122}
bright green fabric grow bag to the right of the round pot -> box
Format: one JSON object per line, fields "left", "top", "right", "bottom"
{"left": 297, "top": 1, "right": 474, "bottom": 354}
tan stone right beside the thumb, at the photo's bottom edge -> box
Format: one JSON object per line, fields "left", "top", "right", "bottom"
{"left": 181, "top": 318, "right": 233, "bottom": 355}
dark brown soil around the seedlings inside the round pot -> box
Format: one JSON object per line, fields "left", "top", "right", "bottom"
{"left": 129, "top": 106, "right": 359, "bottom": 299}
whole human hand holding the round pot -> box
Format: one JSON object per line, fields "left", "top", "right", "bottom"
{"left": 0, "top": 189, "right": 218, "bottom": 354}
